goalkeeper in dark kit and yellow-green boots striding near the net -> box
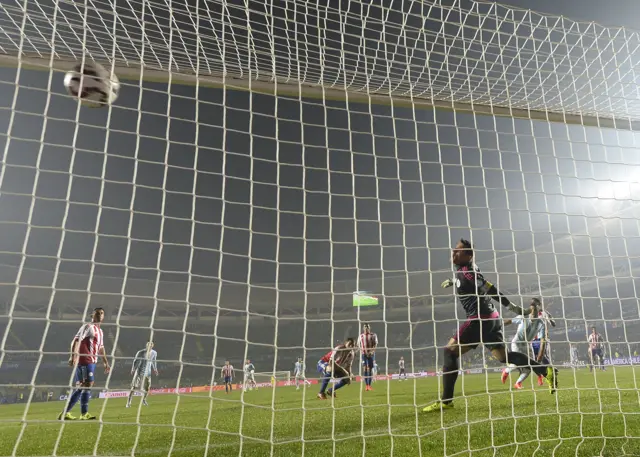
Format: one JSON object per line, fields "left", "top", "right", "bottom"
{"left": 424, "top": 239, "right": 557, "bottom": 412}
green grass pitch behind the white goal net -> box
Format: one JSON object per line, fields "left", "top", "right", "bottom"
{"left": 0, "top": 367, "right": 640, "bottom": 457}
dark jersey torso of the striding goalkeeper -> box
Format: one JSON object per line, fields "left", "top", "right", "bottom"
{"left": 455, "top": 263, "right": 496, "bottom": 318}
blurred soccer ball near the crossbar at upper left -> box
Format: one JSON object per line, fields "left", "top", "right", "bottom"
{"left": 64, "top": 61, "right": 120, "bottom": 108}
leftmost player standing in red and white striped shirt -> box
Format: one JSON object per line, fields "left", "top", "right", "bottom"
{"left": 58, "top": 308, "right": 111, "bottom": 420}
